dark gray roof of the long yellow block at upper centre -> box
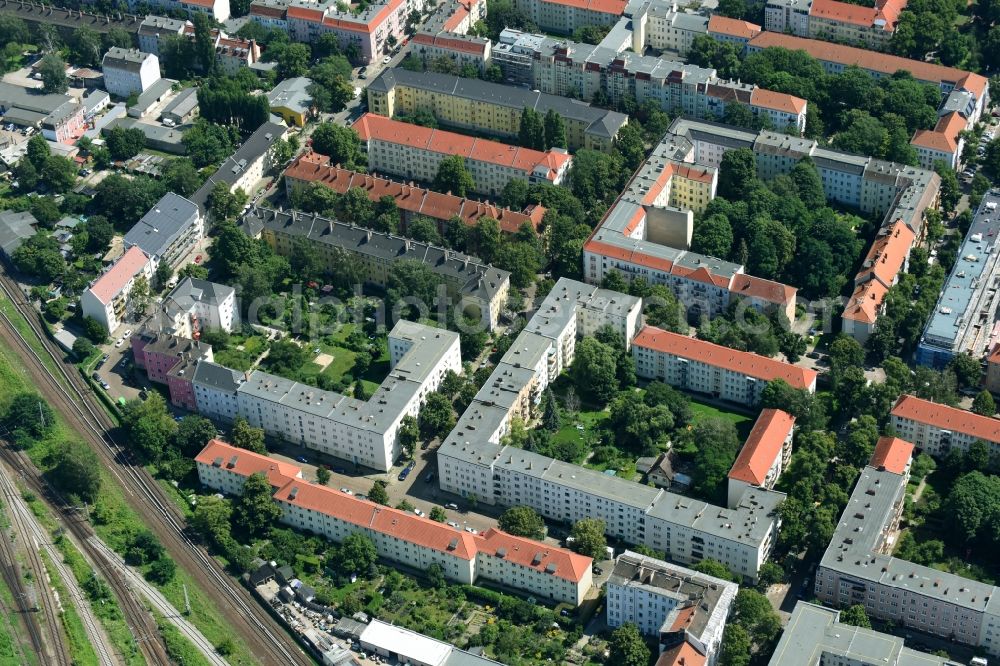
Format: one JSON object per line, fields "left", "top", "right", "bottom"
{"left": 369, "top": 68, "right": 628, "bottom": 138}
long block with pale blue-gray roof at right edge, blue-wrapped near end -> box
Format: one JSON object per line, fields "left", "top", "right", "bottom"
{"left": 916, "top": 189, "right": 1000, "bottom": 368}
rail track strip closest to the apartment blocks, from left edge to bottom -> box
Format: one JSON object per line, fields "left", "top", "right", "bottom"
{"left": 0, "top": 274, "right": 313, "bottom": 666}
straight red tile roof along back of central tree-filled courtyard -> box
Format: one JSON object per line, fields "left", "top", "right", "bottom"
{"left": 632, "top": 326, "right": 816, "bottom": 389}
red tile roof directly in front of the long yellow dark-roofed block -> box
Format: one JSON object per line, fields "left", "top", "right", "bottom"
{"left": 352, "top": 113, "right": 572, "bottom": 180}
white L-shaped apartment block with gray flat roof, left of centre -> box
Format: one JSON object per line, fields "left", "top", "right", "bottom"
{"left": 237, "top": 320, "right": 462, "bottom": 471}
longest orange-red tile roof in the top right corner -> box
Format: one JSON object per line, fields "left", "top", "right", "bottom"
{"left": 750, "top": 31, "right": 987, "bottom": 94}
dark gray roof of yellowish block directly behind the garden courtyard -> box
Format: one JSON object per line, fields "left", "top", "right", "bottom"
{"left": 246, "top": 208, "right": 510, "bottom": 301}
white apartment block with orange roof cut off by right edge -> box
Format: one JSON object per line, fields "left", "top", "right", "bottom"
{"left": 891, "top": 395, "right": 1000, "bottom": 457}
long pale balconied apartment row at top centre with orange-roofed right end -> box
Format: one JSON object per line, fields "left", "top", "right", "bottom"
{"left": 493, "top": 27, "right": 807, "bottom": 133}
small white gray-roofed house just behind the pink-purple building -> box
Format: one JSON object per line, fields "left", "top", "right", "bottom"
{"left": 159, "top": 278, "right": 240, "bottom": 340}
